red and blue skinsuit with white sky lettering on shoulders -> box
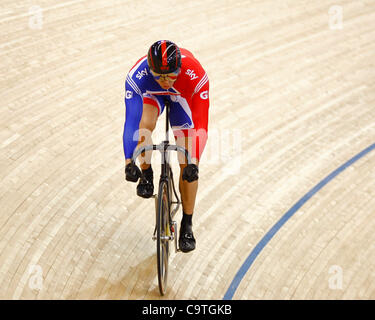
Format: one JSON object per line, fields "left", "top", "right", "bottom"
{"left": 123, "top": 48, "right": 209, "bottom": 160}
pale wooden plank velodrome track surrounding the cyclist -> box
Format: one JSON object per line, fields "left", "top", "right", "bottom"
{"left": 0, "top": 0, "right": 375, "bottom": 299}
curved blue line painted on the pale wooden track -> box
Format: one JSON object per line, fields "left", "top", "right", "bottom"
{"left": 223, "top": 143, "right": 375, "bottom": 300}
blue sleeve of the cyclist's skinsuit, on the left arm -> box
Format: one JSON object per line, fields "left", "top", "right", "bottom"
{"left": 122, "top": 82, "right": 143, "bottom": 159}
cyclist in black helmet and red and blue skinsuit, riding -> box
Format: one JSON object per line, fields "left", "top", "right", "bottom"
{"left": 123, "top": 40, "right": 209, "bottom": 252}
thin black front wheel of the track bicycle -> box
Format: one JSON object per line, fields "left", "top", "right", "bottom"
{"left": 156, "top": 181, "right": 171, "bottom": 295}
